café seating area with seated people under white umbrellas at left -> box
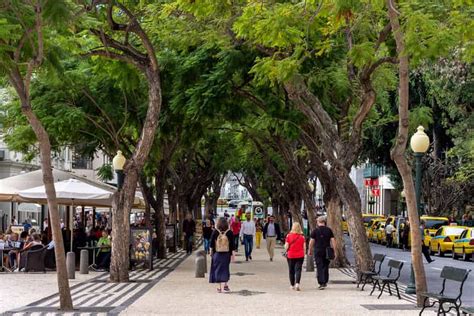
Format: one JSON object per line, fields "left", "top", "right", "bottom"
{"left": 0, "top": 169, "right": 144, "bottom": 272}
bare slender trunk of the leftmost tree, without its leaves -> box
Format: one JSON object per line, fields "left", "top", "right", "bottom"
{"left": 9, "top": 68, "right": 73, "bottom": 311}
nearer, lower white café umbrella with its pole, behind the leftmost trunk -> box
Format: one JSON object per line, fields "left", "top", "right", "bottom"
{"left": 18, "top": 179, "right": 112, "bottom": 251}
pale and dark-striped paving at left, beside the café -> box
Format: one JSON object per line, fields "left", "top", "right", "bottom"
{"left": 4, "top": 251, "right": 186, "bottom": 316}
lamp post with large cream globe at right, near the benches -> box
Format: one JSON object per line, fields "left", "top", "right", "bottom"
{"left": 405, "top": 126, "right": 430, "bottom": 294}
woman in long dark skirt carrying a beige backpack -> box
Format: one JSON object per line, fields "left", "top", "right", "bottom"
{"left": 209, "top": 217, "right": 234, "bottom": 293}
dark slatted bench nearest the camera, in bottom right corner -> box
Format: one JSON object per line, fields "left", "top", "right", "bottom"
{"left": 420, "top": 266, "right": 471, "bottom": 315}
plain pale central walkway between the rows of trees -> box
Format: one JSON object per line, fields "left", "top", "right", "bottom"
{"left": 121, "top": 243, "right": 422, "bottom": 316}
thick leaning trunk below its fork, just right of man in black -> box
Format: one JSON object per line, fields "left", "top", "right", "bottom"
{"left": 334, "top": 170, "right": 372, "bottom": 271}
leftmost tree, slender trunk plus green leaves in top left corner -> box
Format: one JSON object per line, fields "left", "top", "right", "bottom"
{"left": 0, "top": 1, "right": 73, "bottom": 310}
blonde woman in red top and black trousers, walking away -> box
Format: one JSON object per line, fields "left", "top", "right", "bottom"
{"left": 285, "top": 223, "right": 306, "bottom": 291}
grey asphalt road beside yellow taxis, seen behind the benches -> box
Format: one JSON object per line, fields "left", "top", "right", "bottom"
{"left": 346, "top": 236, "right": 474, "bottom": 306}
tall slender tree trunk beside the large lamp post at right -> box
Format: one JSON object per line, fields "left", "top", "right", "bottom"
{"left": 387, "top": 0, "right": 427, "bottom": 306}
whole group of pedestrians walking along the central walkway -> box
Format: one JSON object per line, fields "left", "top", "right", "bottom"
{"left": 200, "top": 212, "right": 335, "bottom": 293}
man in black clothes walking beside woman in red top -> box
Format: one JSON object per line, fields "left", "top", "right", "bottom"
{"left": 309, "top": 216, "right": 336, "bottom": 290}
